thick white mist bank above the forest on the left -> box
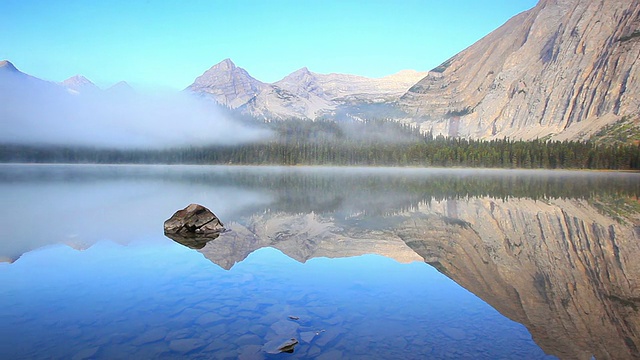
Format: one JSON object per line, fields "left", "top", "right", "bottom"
{"left": 0, "top": 73, "right": 269, "bottom": 149}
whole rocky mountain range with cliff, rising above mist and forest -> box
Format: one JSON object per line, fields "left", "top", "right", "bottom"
{"left": 0, "top": 0, "right": 640, "bottom": 142}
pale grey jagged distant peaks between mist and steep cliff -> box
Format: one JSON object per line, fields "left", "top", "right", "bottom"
{"left": 186, "top": 59, "right": 427, "bottom": 119}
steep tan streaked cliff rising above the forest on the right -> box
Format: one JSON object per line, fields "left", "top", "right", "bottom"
{"left": 401, "top": 0, "right": 640, "bottom": 139}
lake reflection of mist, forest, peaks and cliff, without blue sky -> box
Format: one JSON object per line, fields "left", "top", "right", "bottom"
{"left": 0, "top": 166, "right": 640, "bottom": 359}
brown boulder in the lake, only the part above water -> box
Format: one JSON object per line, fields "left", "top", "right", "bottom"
{"left": 164, "top": 204, "right": 224, "bottom": 236}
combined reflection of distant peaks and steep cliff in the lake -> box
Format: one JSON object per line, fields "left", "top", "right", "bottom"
{"left": 190, "top": 198, "right": 640, "bottom": 359}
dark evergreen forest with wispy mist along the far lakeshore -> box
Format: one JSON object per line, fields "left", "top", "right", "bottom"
{"left": 0, "top": 119, "right": 640, "bottom": 170}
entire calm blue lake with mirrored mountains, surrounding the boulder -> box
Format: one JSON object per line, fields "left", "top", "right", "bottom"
{"left": 0, "top": 164, "right": 640, "bottom": 359}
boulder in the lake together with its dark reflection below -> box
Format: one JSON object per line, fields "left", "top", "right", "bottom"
{"left": 164, "top": 204, "right": 225, "bottom": 243}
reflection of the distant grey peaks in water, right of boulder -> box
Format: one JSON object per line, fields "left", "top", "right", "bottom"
{"left": 199, "top": 213, "right": 422, "bottom": 269}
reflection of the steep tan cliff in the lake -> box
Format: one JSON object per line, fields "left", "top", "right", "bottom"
{"left": 397, "top": 198, "right": 640, "bottom": 359}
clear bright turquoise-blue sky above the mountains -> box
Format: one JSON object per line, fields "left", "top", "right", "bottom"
{"left": 0, "top": 0, "right": 537, "bottom": 90}
